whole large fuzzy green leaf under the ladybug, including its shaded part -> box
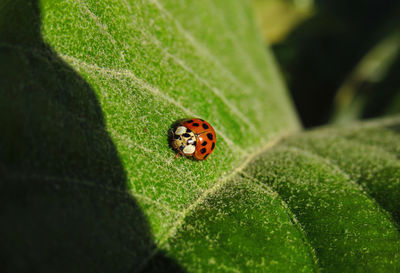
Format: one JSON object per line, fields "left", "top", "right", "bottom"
{"left": 0, "top": 0, "right": 400, "bottom": 272}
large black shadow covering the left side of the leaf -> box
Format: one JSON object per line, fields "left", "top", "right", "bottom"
{"left": 0, "top": 0, "right": 184, "bottom": 272}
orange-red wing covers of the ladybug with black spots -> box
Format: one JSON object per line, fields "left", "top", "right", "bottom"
{"left": 182, "top": 118, "right": 217, "bottom": 160}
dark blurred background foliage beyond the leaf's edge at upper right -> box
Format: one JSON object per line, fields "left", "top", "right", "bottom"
{"left": 253, "top": 0, "right": 400, "bottom": 127}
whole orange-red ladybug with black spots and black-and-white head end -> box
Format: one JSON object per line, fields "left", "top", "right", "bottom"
{"left": 171, "top": 118, "right": 216, "bottom": 160}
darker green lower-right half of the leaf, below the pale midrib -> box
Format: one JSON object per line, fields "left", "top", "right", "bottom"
{"left": 151, "top": 117, "right": 400, "bottom": 272}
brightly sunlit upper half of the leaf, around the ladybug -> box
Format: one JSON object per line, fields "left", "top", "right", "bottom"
{"left": 42, "top": 1, "right": 297, "bottom": 240}
